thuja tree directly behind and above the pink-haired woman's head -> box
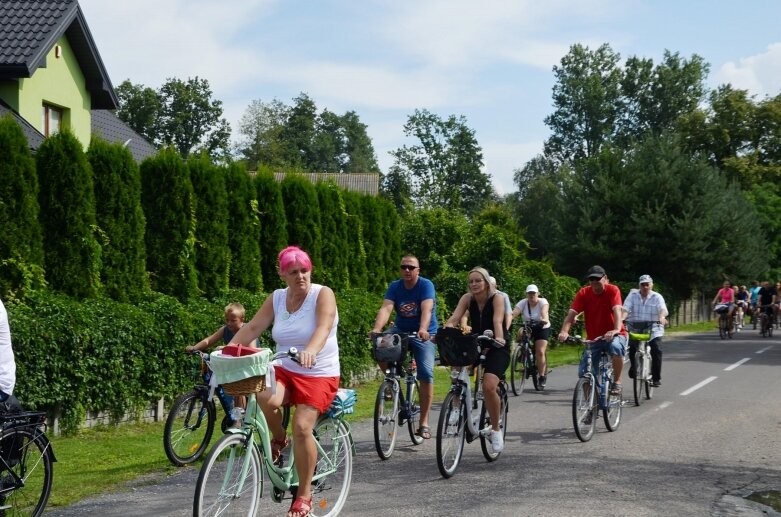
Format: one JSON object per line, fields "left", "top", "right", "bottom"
{"left": 280, "top": 174, "right": 322, "bottom": 270}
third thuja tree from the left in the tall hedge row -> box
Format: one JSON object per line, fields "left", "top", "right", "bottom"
{"left": 87, "top": 139, "right": 149, "bottom": 302}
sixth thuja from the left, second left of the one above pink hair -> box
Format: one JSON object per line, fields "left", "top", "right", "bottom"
{"left": 225, "top": 164, "right": 263, "bottom": 292}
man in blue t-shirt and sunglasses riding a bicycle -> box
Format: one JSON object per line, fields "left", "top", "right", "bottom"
{"left": 372, "top": 255, "right": 437, "bottom": 439}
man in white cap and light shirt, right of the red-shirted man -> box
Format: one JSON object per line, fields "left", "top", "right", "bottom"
{"left": 624, "top": 275, "right": 669, "bottom": 388}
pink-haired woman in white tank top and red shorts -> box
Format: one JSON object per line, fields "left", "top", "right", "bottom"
{"left": 225, "top": 246, "right": 340, "bottom": 517}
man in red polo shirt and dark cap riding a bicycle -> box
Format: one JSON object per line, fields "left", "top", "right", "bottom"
{"left": 559, "top": 266, "right": 627, "bottom": 395}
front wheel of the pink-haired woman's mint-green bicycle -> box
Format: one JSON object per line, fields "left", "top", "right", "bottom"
{"left": 193, "top": 433, "right": 264, "bottom": 517}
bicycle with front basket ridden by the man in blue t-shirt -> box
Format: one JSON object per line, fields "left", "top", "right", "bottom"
{"left": 370, "top": 332, "right": 423, "bottom": 460}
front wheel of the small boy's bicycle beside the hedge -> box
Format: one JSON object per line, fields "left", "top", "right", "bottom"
{"left": 163, "top": 390, "right": 217, "bottom": 467}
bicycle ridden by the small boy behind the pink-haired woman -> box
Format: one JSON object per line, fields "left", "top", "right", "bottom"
{"left": 163, "top": 350, "right": 233, "bottom": 467}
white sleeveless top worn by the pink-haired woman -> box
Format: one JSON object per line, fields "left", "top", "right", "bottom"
{"left": 271, "top": 284, "right": 340, "bottom": 377}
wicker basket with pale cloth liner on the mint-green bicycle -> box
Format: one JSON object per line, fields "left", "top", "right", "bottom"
{"left": 209, "top": 348, "right": 271, "bottom": 396}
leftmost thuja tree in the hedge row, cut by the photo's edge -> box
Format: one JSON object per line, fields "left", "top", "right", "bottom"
{"left": 0, "top": 117, "right": 44, "bottom": 302}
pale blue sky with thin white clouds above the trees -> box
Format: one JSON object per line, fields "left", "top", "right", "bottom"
{"left": 80, "top": 0, "right": 781, "bottom": 193}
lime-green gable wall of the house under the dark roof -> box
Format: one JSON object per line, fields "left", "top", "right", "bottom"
{"left": 0, "top": 36, "right": 92, "bottom": 149}
